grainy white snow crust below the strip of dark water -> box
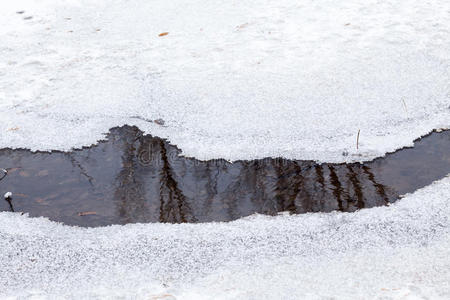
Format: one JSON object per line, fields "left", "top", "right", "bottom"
{"left": 0, "top": 176, "right": 450, "bottom": 299}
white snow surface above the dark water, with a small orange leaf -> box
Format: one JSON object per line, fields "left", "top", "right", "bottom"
{"left": 0, "top": 0, "right": 450, "bottom": 162}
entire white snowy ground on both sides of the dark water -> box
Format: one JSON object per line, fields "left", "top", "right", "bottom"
{"left": 0, "top": 0, "right": 450, "bottom": 299}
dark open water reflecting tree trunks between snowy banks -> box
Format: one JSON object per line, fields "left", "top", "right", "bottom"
{"left": 0, "top": 126, "right": 450, "bottom": 226}
